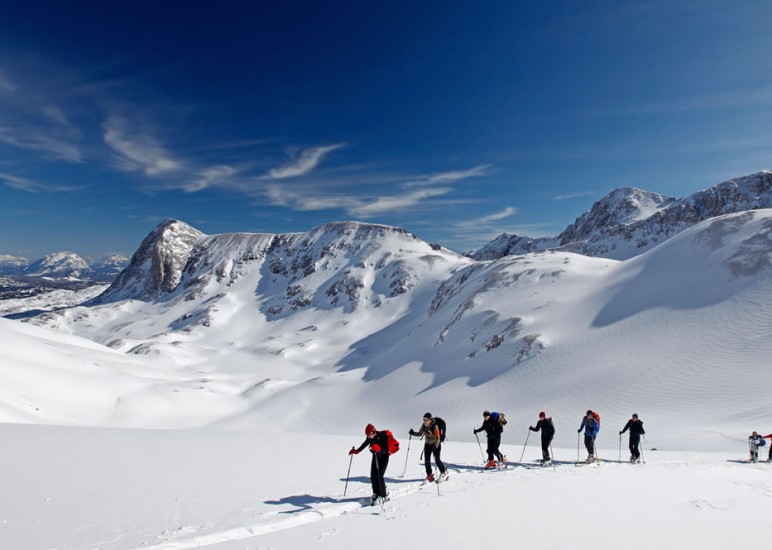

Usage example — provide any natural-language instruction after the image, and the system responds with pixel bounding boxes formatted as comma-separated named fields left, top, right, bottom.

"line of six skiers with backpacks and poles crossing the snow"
left=348, top=410, right=644, bottom=505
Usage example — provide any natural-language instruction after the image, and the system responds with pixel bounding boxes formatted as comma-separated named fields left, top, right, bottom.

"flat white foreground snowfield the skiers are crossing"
left=0, top=422, right=772, bottom=550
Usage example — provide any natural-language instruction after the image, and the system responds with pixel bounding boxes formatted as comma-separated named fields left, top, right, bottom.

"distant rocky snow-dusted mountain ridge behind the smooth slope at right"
left=469, top=170, right=772, bottom=260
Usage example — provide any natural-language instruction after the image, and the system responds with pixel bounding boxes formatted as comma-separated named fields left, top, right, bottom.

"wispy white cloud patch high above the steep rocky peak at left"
left=102, top=116, right=183, bottom=176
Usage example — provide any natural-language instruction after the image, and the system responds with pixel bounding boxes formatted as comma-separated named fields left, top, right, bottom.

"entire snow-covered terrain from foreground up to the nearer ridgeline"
left=0, top=210, right=772, bottom=550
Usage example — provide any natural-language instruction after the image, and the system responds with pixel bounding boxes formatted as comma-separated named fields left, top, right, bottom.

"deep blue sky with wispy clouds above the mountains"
left=0, top=0, right=772, bottom=259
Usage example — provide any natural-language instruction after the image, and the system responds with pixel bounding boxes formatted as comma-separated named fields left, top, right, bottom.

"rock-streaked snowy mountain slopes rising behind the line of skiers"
left=10, top=210, right=772, bottom=448
